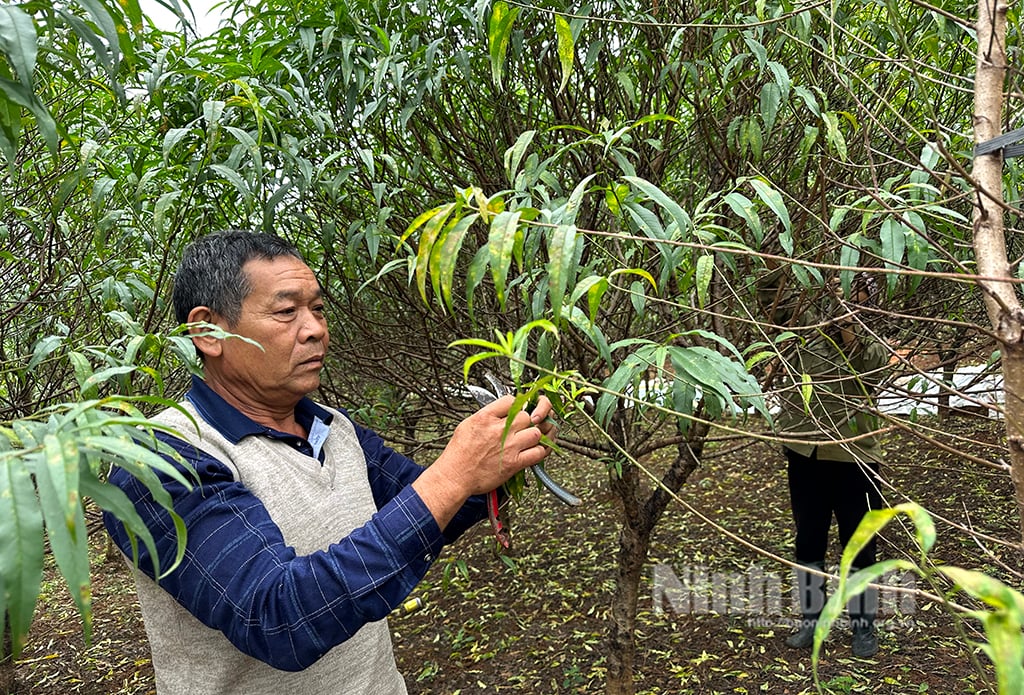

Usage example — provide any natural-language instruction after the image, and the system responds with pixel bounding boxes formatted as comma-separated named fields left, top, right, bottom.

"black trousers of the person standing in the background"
left=785, top=448, right=882, bottom=568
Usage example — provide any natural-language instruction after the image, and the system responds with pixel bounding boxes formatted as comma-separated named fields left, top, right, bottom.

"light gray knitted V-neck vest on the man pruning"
left=135, top=402, right=407, bottom=695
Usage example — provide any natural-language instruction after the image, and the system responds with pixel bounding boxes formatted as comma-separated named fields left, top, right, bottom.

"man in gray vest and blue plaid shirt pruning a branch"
left=105, top=231, right=554, bottom=695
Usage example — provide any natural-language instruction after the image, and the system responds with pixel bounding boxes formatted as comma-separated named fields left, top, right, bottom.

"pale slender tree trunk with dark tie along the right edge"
left=973, top=0, right=1024, bottom=540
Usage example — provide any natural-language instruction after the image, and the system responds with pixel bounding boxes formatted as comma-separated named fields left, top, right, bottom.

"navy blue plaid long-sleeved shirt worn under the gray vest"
left=104, top=379, right=486, bottom=670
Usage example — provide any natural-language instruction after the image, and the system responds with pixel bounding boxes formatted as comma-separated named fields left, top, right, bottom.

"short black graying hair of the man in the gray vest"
left=173, top=229, right=304, bottom=325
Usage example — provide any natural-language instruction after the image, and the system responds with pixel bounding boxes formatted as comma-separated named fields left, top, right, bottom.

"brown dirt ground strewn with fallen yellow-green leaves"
left=6, top=420, right=1020, bottom=695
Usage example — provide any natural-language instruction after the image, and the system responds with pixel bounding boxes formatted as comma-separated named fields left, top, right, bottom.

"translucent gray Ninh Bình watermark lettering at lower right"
left=651, top=563, right=918, bottom=629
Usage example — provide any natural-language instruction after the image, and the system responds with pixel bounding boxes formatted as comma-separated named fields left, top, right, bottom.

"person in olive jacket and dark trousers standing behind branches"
left=760, top=271, right=889, bottom=658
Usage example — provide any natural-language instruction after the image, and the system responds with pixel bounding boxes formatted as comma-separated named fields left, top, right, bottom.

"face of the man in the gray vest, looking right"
left=214, top=256, right=330, bottom=408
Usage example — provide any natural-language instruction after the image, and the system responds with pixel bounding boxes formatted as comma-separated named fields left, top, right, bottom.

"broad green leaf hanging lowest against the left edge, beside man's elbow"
left=0, top=450, right=43, bottom=658
